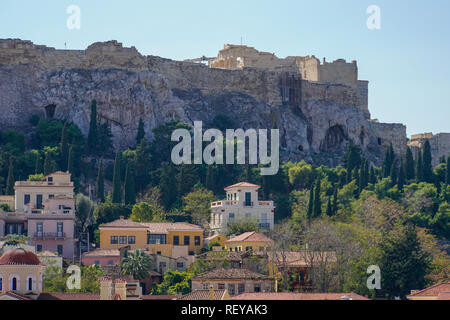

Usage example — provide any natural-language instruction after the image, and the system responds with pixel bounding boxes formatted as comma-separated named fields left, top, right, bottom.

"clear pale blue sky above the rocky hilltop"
left=0, top=0, right=450, bottom=135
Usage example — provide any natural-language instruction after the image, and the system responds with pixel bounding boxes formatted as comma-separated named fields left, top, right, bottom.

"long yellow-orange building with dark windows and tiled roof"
left=99, top=217, right=203, bottom=257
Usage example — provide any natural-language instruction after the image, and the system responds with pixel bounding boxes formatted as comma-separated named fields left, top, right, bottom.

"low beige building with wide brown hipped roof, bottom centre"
left=191, top=268, right=274, bottom=295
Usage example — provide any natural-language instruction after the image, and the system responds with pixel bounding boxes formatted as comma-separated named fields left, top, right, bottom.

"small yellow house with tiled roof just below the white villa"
left=225, top=231, right=273, bottom=252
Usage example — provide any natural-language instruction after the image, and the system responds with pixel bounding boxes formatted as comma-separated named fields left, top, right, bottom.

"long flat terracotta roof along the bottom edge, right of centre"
left=231, top=292, right=370, bottom=300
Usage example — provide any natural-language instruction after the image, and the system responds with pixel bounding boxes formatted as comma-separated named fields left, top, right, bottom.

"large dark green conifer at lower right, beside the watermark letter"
left=380, top=224, right=430, bottom=298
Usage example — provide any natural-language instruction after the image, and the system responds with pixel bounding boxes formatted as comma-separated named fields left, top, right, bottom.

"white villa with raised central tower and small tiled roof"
left=210, top=182, right=275, bottom=233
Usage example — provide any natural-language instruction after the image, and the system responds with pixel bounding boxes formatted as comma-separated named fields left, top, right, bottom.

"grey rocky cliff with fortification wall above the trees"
left=0, top=40, right=406, bottom=166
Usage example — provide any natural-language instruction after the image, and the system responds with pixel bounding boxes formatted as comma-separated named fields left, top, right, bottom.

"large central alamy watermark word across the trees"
left=171, top=121, right=280, bottom=175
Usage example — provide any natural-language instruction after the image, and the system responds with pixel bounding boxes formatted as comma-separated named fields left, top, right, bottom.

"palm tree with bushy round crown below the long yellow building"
left=120, top=249, right=153, bottom=280
